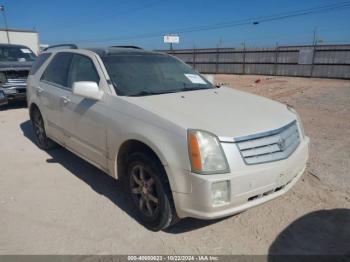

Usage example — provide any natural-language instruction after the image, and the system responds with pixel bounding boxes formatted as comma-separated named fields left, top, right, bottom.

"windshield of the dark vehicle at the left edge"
left=0, top=46, right=35, bottom=62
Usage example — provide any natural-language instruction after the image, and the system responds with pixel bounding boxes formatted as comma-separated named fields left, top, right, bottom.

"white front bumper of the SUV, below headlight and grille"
left=173, top=137, right=309, bottom=219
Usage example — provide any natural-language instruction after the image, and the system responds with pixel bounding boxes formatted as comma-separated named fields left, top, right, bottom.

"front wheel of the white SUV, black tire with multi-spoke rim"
left=123, top=152, right=178, bottom=231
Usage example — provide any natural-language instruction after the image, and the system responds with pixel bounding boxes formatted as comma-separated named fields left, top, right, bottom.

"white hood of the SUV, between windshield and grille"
left=128, top=87, right=296, bottom=140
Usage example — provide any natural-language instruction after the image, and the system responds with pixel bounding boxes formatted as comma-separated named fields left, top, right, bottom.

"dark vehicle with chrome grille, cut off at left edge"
left=0, top=44, right=36, bottom=105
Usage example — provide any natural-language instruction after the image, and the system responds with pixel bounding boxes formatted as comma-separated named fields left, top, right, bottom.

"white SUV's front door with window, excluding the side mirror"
left=62, top=53, right=107, bottom=170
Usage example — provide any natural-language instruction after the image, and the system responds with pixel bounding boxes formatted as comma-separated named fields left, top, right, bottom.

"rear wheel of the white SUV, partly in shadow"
left=30, top=108, right=56, bottom=150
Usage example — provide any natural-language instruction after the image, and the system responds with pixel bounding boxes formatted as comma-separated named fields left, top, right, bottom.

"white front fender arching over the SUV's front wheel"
left=102, top=95, right=190, bottom=193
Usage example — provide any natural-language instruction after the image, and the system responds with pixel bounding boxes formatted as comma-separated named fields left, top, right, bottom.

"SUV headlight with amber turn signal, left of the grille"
left=187, top=130, right=230, bottom=174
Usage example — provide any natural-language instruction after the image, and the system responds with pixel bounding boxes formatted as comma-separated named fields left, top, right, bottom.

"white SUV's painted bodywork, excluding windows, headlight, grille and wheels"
left=27, top=49, right=309, bottom=219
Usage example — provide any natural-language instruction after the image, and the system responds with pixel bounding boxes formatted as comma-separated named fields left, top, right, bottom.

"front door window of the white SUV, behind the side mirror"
left=68, top=54, right=100, bottom=88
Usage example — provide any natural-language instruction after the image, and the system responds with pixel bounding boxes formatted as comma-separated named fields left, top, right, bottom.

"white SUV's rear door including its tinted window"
left=38, top=52, right=73, bottom=144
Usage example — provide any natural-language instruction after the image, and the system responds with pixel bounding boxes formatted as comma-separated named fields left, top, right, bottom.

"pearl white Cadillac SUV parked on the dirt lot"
left=27, top=45, right=309, bottom=231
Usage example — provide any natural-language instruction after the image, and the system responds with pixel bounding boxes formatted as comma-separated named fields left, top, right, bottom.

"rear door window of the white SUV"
left=41, top=53, right=73, bottom=87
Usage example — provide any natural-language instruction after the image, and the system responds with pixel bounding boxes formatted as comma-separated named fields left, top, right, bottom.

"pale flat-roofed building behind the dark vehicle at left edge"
left=0, top=28, right=40, bottom=54
